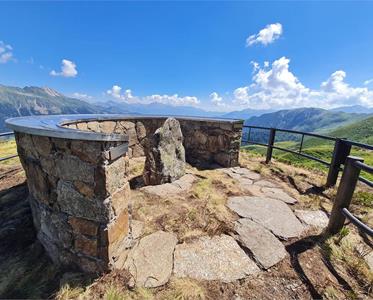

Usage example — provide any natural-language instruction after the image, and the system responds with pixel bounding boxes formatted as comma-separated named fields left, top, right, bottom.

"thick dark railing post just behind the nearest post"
left=326, top=139, right=351, bottom=187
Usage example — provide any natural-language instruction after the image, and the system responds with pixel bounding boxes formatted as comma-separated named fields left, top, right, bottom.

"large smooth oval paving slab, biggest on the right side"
left=228, top=196, right=304, bottom=239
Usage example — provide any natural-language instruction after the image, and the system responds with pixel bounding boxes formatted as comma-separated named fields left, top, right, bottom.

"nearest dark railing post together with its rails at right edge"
left=327, top=156, right=373, bottom=237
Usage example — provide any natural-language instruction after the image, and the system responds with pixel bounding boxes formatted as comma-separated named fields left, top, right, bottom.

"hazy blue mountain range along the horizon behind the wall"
left=0, top=85, right=373, bottom=132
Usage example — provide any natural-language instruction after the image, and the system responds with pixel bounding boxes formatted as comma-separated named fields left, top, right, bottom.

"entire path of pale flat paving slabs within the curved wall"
left=120, top=167, right=328, bottom=287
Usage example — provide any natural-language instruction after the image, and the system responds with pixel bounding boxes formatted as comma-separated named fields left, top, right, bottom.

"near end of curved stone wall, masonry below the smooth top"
left=16, top=132, right=130, bottom=273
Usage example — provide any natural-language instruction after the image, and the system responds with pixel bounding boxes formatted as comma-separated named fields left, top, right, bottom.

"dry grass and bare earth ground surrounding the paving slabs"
left=0, top=153, right=373, bottom=299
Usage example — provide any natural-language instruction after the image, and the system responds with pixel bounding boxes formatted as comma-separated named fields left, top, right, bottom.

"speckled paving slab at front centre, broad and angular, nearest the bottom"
left=174, top=235, right=259, bottom=282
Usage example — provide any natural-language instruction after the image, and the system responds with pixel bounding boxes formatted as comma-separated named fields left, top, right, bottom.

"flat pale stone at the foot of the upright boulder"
left=141, top=174, right=196, bottom=197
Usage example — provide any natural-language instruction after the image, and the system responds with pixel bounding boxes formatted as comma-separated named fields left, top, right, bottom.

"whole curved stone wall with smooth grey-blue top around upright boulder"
left=6, top=115, right=242, bottom=273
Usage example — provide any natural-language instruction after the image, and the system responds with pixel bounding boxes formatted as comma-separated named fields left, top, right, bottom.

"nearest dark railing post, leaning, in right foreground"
left=326, top=156, right=364, bottom=234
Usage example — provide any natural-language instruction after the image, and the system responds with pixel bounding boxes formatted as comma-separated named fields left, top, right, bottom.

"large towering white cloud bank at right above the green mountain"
left=233, top=57, right=373, bottom=108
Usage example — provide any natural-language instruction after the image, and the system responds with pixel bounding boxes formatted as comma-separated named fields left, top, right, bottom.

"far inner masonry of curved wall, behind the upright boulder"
left=65, top=117, right=242, bottom=167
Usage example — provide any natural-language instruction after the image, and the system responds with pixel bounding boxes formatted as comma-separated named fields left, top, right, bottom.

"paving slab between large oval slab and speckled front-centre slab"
left=235, top=219, right=287, bottom=269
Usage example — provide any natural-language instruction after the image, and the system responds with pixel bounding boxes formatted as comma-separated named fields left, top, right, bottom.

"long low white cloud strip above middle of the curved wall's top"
left=106, top=85, right=200, bottom=106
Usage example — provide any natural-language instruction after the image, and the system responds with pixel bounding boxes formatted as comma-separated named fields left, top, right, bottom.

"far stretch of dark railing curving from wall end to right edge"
left=242, top=125, right=373, bottom=186
